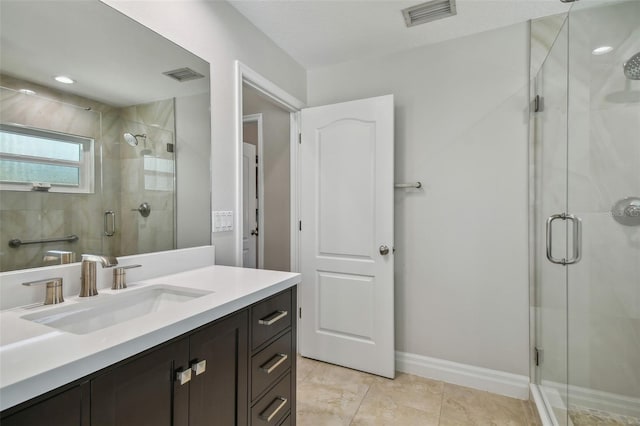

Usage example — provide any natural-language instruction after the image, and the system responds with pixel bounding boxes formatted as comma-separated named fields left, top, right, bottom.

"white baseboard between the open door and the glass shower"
left=396, top=352, right=529, bottom=400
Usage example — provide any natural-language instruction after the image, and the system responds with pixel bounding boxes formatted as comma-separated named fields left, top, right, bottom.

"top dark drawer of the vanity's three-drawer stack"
left=251, top=290, right=294, bottom=350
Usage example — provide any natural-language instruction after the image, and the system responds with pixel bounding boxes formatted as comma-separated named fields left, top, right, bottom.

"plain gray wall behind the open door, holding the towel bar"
left=308, top=23, right=529, bottom=376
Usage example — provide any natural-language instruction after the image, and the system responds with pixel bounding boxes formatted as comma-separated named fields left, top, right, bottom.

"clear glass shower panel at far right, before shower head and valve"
left=567, top=0, right=640, bottom=426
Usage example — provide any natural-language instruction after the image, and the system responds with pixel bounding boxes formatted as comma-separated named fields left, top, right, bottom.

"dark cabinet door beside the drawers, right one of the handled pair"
left=189, top=311, right=249, bottom=426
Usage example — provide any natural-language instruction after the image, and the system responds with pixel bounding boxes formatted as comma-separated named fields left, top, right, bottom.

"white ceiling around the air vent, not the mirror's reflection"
left=227, top=0, right=570, bottom=69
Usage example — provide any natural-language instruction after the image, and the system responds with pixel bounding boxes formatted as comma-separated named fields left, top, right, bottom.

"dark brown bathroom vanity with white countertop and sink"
left=0, top=266, right=300, bottom=426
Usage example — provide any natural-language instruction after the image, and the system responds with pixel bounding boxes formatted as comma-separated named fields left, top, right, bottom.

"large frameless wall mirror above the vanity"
left=0, top=0, right=211, bottom=271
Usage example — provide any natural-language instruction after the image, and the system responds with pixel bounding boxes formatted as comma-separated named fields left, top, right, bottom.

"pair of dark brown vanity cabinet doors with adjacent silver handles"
left=91, top=310, right=248, bottom=426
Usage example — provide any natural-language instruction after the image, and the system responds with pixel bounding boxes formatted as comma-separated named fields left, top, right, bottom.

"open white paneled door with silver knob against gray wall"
left=299, top=95, right=395, bottom=378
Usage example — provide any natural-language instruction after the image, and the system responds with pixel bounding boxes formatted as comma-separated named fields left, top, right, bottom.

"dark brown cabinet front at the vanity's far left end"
left=2, top=384, right=89, bottom=426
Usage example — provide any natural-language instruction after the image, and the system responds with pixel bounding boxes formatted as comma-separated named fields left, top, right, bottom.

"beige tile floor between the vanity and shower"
left=296, top=357, right=541, bottom=426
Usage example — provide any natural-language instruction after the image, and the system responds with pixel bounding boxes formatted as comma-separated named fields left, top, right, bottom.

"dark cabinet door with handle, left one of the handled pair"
left=91, top=338, right=189, bottom=426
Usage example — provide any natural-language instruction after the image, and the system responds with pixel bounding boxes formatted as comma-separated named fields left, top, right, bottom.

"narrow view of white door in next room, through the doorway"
left=242, top=142, right=258, bottom=268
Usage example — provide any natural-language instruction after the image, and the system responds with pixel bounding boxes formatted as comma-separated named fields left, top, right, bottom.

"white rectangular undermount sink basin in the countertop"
left=21, top=285, right=213, bottom=334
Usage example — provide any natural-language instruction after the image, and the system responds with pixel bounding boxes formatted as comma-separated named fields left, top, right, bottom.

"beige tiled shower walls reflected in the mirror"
left=0, top=76, right=175, bottom=271
